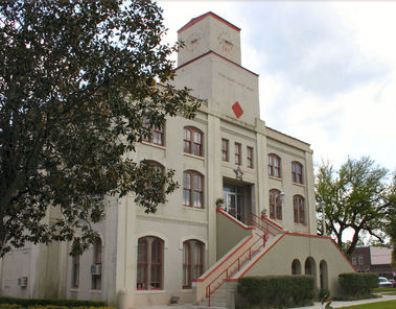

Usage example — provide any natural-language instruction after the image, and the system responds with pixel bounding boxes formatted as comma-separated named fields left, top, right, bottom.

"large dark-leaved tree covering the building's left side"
left=0, top=0, right=198, bottom=256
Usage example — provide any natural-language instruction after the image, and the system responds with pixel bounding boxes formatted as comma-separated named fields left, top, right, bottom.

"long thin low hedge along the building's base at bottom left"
left=0, top=297, right=106, bottom=309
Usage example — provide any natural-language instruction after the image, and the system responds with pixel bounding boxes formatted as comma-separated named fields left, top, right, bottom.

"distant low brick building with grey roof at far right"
left=351, top=247, right=396, bottom=278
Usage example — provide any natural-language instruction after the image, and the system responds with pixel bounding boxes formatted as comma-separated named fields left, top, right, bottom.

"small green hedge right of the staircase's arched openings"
left=338, top=273, right=378, bottom=299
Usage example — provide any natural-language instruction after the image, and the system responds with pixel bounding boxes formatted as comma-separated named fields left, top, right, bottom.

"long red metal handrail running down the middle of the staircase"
left=206, top=234, right=267, bottom=307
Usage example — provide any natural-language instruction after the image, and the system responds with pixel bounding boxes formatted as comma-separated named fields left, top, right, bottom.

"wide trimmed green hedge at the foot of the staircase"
left=236, top=276, right=315, bottom=309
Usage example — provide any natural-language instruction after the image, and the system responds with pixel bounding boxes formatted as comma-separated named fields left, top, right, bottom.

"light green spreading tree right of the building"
left=315, top=157, right=395, bottom=255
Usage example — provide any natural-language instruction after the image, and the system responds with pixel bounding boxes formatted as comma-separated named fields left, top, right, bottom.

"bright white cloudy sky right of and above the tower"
left=159, top=0, right=396, bottom=170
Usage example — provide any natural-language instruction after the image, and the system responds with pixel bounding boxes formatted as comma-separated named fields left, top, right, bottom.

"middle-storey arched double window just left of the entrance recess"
left=183, top=170, right=204, bottom=208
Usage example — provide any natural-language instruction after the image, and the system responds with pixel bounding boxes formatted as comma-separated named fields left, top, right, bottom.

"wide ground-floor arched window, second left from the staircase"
left=136, top=236, right=164, bottom=290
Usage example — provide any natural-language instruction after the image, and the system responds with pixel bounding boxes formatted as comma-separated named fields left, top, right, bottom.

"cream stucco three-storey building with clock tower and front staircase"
left=1, top=12, right=353, bottom=308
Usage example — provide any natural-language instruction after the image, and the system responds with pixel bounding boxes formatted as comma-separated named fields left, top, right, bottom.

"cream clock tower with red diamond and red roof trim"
left=175, top=12, right=260, bottom=126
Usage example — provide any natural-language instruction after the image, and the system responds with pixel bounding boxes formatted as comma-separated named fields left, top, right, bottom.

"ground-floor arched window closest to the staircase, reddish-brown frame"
left=183, top=239, right=204, bottom=289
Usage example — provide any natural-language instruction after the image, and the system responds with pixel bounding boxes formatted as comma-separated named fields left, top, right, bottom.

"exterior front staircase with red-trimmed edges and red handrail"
left=195, top=209, right=285, bottom=308
